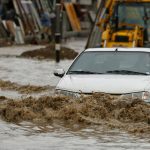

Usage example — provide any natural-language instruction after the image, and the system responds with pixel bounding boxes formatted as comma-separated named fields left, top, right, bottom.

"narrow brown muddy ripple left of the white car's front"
left=0, top=80, right=53, bottom=94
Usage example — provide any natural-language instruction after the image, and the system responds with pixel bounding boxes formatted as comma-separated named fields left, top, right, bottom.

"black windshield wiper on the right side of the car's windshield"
left=106, top=70, right=149, bottom=75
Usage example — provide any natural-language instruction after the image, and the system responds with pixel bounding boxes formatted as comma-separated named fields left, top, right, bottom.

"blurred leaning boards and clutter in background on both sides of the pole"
left=0, top=0, right=98, bottom=44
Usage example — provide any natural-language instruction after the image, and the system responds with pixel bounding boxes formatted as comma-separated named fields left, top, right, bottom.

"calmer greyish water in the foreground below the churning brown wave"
left=0, top=122, right=150, bottom=150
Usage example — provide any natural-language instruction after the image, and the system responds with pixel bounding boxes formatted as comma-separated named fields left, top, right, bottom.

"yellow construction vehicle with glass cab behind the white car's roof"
left=97, top=0, right=150, bottom=47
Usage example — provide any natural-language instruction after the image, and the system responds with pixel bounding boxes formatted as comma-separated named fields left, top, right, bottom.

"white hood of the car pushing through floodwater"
left=56, top=75, right=150, bottom=94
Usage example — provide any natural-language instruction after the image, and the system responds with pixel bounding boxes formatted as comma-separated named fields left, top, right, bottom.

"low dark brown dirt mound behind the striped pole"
left=20, top=44, right=78, bottom=59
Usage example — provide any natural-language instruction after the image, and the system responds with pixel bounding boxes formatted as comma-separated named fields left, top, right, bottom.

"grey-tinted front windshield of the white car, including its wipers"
left=67, top=51, right=150, bottom=75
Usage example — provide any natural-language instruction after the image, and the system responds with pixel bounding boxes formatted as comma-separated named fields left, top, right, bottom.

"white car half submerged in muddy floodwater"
left=54, top=48, right=150, bottom=101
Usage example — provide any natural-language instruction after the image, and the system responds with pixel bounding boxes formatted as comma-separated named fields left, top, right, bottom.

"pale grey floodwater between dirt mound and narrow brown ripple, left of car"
left=0, top=57, right=72, bottom=86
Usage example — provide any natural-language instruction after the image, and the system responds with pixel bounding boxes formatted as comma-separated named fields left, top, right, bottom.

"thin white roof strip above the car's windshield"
left=85, top=47, right=150, bottom=52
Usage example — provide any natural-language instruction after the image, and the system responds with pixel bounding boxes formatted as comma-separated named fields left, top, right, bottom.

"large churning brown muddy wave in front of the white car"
left=0, top=93, right=150, bottom=134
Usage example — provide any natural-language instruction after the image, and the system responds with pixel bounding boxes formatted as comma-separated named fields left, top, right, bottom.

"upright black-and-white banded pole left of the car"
left=55, top=0, right=61, bottom=63
